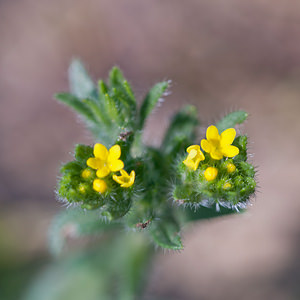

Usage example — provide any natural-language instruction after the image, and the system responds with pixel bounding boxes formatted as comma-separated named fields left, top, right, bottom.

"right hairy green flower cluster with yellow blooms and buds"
left=173, top=125, right=256, bottom=208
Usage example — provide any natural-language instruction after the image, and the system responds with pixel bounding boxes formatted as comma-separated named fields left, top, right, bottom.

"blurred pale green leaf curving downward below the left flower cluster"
left=49, top=208, right=119, bottom=255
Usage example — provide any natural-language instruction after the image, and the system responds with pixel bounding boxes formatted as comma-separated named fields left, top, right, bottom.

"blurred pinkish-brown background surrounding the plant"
left=0, top=0, right=300, bottom=300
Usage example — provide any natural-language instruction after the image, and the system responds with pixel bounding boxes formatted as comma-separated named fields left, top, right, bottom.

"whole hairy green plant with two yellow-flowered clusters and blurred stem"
left=24, top=60, right=256, bottom=299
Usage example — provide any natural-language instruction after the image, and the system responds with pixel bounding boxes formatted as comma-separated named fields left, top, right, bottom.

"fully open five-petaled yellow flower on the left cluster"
left=86, top=144, right=124, bottom=178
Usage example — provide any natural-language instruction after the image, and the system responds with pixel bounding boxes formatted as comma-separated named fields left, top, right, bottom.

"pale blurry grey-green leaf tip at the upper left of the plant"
left=69, top=59, right=96, bottom=98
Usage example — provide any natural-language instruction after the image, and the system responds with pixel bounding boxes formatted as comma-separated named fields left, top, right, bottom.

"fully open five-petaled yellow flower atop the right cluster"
left=201, top=125, right=239, bottom=160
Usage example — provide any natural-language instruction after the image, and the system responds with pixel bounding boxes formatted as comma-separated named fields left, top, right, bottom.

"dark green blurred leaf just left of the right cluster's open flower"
left=161, top=105, right=199, bottom=155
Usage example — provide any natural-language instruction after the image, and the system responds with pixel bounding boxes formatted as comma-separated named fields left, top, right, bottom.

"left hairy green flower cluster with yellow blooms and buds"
left=58, top=143, right=135, bottom=209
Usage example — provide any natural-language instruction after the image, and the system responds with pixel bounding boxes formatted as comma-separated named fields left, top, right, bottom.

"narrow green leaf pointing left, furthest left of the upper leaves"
left=54, top=93, right=96, bottom=123
